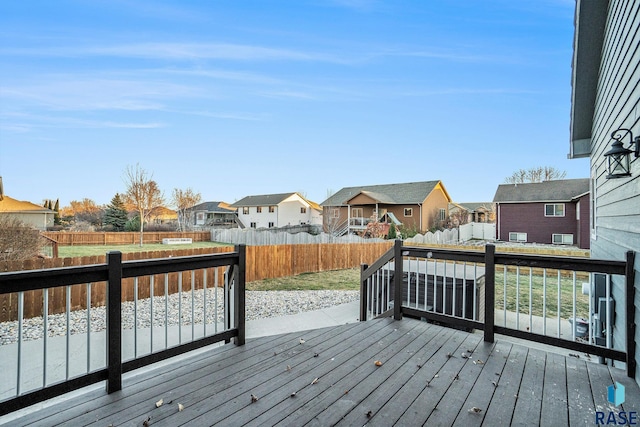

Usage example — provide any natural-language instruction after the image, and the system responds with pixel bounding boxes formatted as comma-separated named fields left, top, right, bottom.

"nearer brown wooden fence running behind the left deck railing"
left=0, top=242, right=392, bottom=322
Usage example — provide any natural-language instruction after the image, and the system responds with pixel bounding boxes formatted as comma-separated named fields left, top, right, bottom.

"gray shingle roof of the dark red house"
left=493, top=178, right=589, bottom=203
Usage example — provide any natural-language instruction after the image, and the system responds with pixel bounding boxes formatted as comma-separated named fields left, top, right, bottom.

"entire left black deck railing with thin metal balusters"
left=0, top=245, right=246, bottom=415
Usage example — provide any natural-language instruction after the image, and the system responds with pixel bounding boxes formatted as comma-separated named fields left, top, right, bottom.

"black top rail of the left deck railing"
left=0, top=251, right=239, bottom=294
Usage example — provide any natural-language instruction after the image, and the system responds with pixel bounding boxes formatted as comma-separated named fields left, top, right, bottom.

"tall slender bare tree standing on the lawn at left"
left=123, top=164, right=164, bottom=246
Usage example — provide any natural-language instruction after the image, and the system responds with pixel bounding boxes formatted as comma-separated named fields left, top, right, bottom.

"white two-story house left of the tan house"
left=231, top=193, right=322, bottom=228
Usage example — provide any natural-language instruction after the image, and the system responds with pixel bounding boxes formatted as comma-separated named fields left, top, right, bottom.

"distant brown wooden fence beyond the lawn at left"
left=42, top=231, right=211, bottom=246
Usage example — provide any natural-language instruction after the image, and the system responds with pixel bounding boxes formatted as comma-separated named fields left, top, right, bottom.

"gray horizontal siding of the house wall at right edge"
left=572, top=0, right=640, bottom=382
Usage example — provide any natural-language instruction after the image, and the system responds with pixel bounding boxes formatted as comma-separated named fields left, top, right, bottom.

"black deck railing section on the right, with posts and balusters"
left=360, top=240, right=636, bottom=376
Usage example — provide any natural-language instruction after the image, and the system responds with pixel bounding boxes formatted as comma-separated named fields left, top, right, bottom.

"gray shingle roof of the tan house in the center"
left=320, top=181, right=440, bottom=206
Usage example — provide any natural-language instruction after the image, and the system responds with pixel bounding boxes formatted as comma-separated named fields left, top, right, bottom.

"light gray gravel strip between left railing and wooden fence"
left=0, top=288, right=360, bottom=345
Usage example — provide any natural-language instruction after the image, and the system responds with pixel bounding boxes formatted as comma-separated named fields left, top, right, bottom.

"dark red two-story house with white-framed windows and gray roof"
left=493, top=178, right=590, bottom=249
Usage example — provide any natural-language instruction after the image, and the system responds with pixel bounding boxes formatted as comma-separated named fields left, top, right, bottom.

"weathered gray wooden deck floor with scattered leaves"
left=6, top=319, right=640, bottom=426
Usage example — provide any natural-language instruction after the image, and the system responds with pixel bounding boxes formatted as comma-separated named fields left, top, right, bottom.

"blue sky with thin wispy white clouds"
left=0, top=0, right=589, bottom=206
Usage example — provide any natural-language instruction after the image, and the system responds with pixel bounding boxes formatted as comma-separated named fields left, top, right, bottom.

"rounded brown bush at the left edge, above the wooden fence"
left=0, top=215, right=44, bottom=261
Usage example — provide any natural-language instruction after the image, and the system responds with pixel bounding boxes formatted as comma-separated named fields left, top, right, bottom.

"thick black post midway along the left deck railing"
left=107, top=251, right=122, bottom=393
